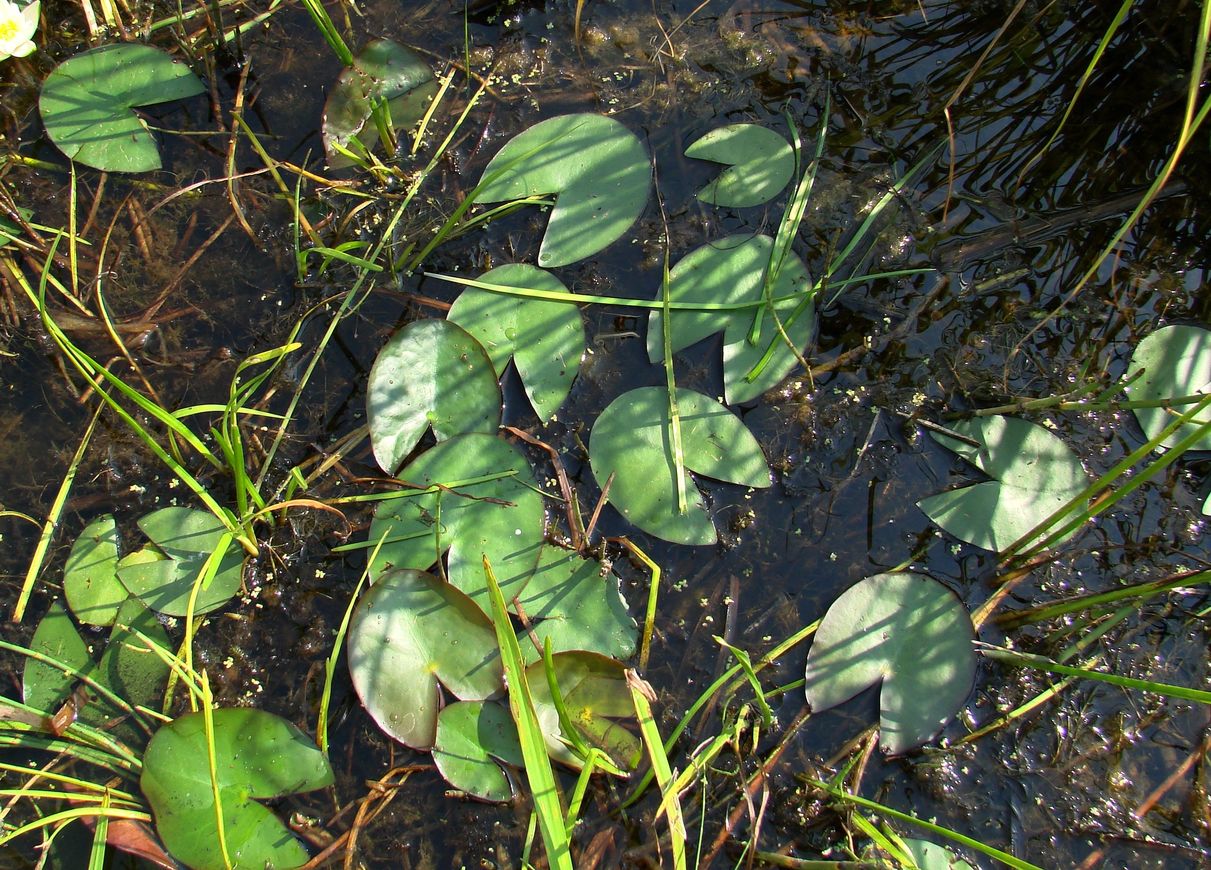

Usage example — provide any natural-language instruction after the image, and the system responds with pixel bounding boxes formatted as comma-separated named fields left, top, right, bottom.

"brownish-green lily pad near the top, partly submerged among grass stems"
left=323, top=39, right=437, bottom=165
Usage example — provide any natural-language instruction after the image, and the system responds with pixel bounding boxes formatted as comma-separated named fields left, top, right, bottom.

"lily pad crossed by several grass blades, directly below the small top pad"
left=648, top=235, right=815, bottom=403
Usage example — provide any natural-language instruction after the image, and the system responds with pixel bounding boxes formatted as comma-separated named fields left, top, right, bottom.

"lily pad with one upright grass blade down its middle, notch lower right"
left=589, top=387, right=770, bottom=545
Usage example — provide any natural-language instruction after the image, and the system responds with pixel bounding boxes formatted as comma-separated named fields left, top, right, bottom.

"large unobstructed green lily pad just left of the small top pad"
left=476, top=114, right=652, bottom=268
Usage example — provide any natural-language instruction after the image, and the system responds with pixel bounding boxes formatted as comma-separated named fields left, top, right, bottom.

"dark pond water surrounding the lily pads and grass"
left=0, top=0, right=1211, bottom=868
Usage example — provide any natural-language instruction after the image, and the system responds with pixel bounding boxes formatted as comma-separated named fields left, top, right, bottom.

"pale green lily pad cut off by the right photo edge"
left=1126, top=326, right=1211, bottom=450
